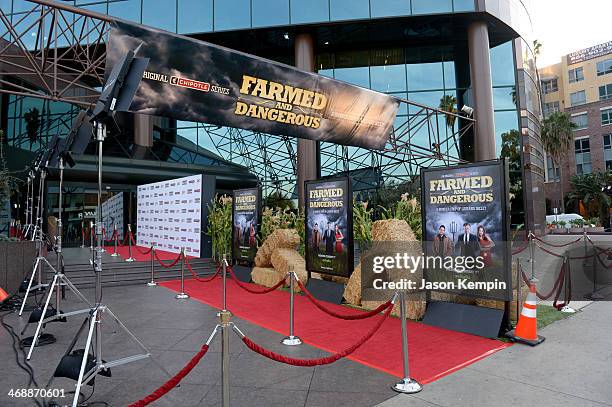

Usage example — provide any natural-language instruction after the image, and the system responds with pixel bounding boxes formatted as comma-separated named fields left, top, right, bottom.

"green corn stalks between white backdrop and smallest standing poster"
left=206, top=195, right=232, bottom=260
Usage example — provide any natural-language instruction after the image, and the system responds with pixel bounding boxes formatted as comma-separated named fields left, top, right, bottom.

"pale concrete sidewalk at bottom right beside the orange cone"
left=379, top=302, right=612, bottom=407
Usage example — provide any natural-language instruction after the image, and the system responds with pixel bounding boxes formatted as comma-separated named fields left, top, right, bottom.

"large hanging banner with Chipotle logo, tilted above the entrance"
left=106, top=21, right=399, bottom=149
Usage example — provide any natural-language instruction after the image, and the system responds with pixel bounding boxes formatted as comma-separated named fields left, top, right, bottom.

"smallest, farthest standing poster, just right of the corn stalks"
left=232, top=188, right=261, bottom=263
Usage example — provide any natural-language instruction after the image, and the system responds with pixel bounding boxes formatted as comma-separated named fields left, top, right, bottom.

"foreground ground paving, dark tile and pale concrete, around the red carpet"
left=0, top=256, right=612, bottom=407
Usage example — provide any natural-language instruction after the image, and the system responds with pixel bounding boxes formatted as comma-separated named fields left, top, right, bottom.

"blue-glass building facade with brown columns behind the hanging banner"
left=0, top=0, right=546, bottom=230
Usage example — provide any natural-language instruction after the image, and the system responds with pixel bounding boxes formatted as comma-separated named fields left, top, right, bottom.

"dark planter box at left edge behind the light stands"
left=0, top=241, right=36, bottom=294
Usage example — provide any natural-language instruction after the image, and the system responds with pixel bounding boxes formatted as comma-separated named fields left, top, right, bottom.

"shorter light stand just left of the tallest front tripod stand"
left=22, top=157, right=92, bottom=360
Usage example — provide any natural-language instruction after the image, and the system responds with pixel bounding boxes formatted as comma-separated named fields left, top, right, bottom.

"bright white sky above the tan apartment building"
left=530, top=0, right=612, bottom=68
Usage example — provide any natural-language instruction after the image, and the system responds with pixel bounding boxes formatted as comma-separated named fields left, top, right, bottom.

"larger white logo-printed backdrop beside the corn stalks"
left=136, top=175, right=202, bottom=257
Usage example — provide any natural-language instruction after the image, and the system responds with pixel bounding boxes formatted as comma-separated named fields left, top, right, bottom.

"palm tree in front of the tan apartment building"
left=541, top=112, right=576, bottom=213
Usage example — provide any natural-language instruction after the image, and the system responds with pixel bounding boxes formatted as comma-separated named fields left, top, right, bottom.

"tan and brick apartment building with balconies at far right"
left=540, top=41, right=612, bottom=211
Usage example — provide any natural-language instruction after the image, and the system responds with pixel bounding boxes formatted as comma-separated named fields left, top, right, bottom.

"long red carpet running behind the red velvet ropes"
left=160, top=278, right=511, bottom=383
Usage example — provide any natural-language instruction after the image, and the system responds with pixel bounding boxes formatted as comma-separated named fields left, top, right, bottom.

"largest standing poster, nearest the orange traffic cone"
left=421, top=160, right=512, bottom=300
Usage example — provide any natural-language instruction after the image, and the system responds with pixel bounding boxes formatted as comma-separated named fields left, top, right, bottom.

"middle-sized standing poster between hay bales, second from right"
left=304, top=178, right=353, bottom=277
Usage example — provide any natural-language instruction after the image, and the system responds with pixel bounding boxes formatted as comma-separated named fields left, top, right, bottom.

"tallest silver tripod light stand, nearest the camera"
left=52, top=123, right=171, bottom=407
